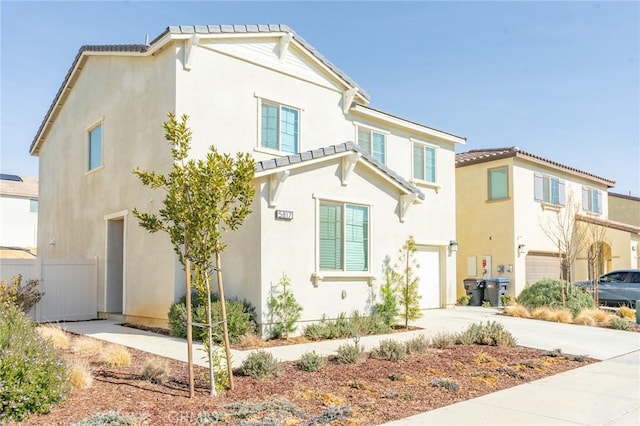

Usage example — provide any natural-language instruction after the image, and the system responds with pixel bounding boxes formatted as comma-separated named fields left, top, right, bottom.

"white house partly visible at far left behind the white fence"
left=0, top=173, right=38, bottom=258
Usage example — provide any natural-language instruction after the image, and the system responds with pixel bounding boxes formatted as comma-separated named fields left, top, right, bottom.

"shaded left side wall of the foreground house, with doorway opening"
left=38, top=46, right=175, bottom=319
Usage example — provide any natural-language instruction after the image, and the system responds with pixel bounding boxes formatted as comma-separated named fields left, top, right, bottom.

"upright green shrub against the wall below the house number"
left=267, top=274, right=302, bottom=339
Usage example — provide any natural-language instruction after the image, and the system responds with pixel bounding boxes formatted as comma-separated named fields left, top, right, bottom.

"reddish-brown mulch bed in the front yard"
left=16, top=336, right=594, bottom=426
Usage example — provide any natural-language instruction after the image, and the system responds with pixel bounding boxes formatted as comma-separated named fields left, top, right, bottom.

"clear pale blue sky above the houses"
left=0, top=0, right=640, bottom=196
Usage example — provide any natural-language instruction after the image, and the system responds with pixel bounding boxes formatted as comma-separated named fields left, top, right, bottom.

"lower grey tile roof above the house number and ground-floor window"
left=256, top=142, right=425, bottom=200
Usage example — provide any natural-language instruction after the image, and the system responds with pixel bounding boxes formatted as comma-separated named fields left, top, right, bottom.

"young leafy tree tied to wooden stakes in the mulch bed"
left=133, top=113, right=255, bottom=395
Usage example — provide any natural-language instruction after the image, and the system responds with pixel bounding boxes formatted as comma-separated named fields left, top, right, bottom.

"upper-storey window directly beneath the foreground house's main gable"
left=260, top=102, right=300, bottom=154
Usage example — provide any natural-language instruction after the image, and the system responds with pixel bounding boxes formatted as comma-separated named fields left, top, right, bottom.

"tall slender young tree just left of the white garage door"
left=395, top=236, right=422, bottom=328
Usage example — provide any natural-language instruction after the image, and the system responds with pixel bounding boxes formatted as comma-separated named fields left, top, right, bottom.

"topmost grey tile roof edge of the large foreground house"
left=29, top=25, right=370, bottom=153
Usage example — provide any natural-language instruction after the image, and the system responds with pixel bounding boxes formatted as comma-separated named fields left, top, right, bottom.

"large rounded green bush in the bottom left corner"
left=0, top=304, right=69, bottom=423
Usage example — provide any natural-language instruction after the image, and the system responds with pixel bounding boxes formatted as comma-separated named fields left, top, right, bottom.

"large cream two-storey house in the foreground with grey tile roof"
left=31, top=25, right=465, bottom=325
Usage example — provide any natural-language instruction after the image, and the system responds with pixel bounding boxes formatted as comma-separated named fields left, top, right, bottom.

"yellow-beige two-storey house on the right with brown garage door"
left=456, top=147, right=640, bottom=296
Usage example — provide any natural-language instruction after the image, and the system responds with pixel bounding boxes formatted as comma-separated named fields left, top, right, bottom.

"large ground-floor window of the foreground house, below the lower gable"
left=319, top=202, right=369, bottom=272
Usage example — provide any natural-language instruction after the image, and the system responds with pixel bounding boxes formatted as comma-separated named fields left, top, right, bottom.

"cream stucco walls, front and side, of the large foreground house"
left=38, top=36, right=456, bottom=325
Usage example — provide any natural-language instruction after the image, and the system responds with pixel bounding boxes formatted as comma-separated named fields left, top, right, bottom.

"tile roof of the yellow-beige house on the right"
left=456, top=146, right=616, bottom=187
